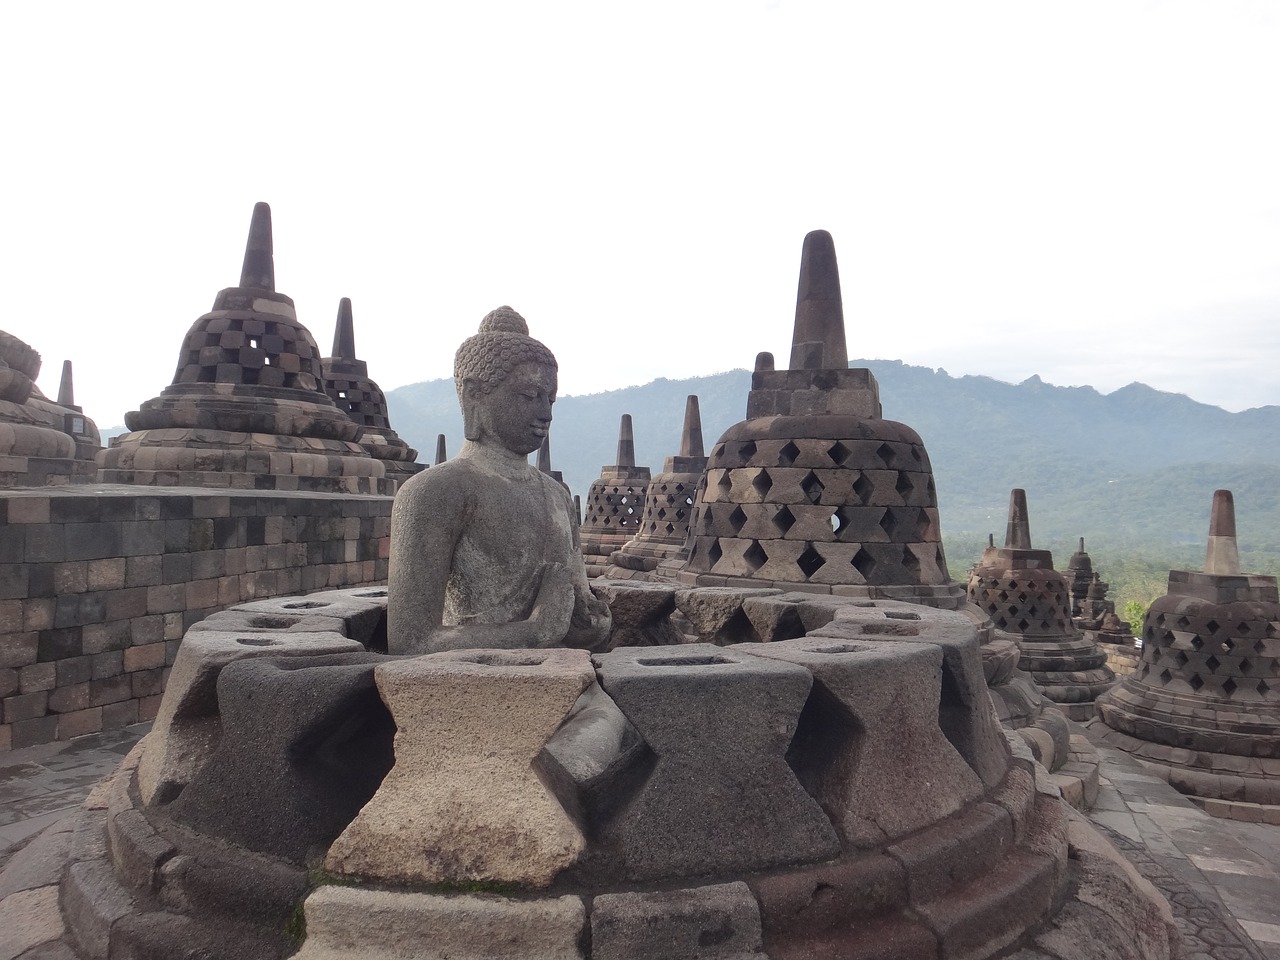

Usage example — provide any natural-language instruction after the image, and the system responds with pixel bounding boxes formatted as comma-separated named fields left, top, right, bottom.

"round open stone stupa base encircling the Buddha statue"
left=6, top=585, right=1175, bottom=960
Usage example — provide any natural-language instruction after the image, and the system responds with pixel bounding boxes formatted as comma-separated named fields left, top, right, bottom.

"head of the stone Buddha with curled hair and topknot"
left=453, top=306, right=558, bottom=456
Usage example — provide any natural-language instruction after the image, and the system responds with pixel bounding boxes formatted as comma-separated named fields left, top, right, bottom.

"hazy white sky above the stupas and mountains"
left=0, top=0, right=1280, bottom=428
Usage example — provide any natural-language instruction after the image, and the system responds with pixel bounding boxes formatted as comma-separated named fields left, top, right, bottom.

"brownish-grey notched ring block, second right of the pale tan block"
left=730, top=637, right=982, bottom=847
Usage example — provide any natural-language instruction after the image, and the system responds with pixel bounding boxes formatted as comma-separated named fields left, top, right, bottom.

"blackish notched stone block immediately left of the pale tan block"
left=169, top=653, right=394, bottom=863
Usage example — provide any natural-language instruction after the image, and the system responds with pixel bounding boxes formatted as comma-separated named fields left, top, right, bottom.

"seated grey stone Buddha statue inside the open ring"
left=387, top=306, right=611, bottom=654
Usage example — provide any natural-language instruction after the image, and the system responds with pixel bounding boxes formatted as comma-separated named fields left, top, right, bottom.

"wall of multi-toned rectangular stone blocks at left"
left=0, top=485, right=392, bottom=750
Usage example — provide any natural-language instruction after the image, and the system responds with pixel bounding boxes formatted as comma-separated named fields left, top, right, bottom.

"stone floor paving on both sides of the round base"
left=0, top=723, right=1280, bottom=960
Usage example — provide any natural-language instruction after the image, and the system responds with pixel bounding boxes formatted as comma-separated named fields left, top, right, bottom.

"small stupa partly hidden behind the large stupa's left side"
left=605, top=394, right=707, bottom=580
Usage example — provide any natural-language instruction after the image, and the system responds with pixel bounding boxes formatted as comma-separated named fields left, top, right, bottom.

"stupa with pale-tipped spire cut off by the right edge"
left=1092, top=490, right=1280, bottom=823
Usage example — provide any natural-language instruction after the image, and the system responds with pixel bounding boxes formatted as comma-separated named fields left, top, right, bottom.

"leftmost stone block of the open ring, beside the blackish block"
left=138, top=631, right=364, bottom=805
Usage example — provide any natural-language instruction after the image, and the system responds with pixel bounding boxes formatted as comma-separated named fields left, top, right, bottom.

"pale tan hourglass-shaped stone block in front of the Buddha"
left=326, top=648, right=595, bottom=887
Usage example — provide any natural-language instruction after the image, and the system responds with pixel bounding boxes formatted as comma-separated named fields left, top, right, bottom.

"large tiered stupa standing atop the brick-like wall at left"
left=99, top=204, right=396, bottom=494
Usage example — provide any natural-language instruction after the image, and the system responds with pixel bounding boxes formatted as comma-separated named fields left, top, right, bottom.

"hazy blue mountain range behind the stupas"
left=387, top=360, right=1280, bottom=563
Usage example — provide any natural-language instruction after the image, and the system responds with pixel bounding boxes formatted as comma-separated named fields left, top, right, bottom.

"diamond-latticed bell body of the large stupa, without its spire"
left=681, top=415, right=950, bottom=593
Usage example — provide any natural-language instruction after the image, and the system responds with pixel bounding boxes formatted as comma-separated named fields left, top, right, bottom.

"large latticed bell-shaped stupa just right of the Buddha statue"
left=678, top=230, right=964, bottom=608
